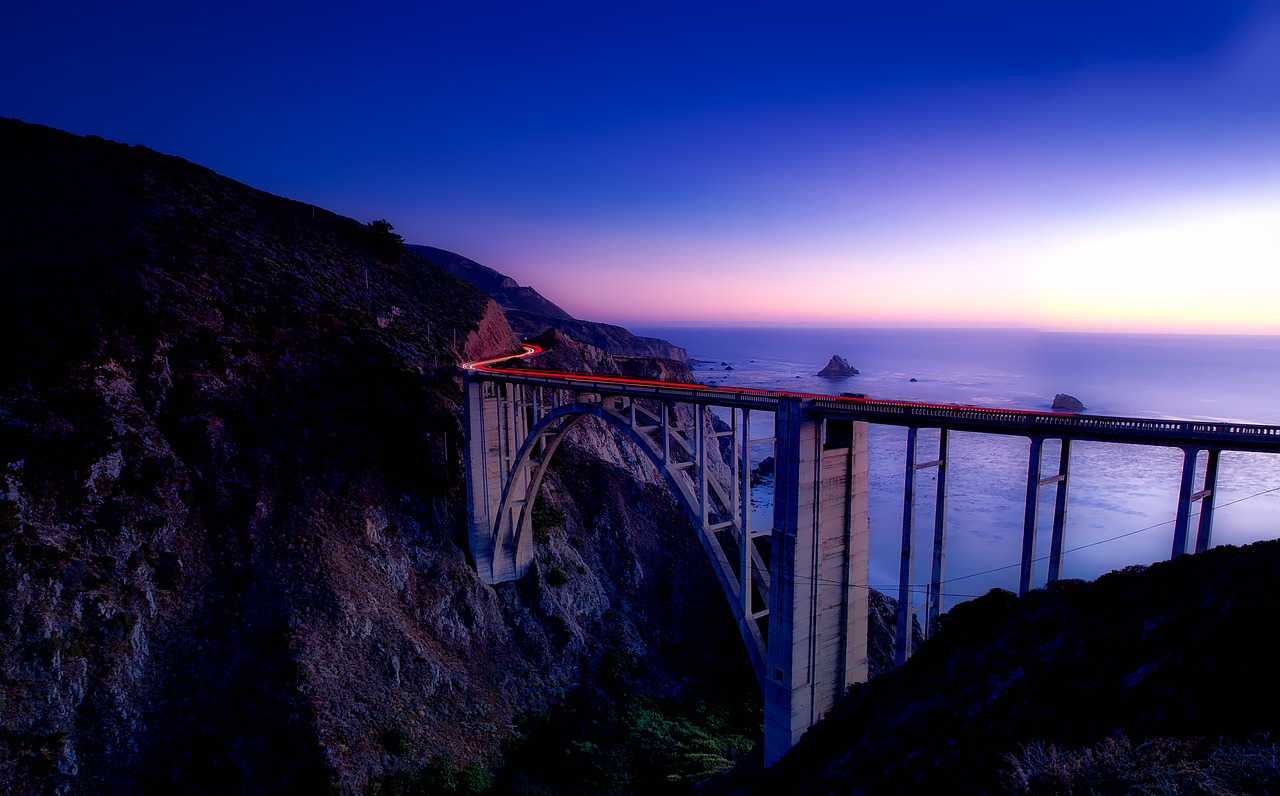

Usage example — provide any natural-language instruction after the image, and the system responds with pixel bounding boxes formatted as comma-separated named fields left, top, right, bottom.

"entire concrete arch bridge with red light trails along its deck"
left=463, top=346, right=1280, bottom=765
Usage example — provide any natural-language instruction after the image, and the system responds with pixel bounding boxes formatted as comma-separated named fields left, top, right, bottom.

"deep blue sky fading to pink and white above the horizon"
left=0, top=0, right=1280, bottom=334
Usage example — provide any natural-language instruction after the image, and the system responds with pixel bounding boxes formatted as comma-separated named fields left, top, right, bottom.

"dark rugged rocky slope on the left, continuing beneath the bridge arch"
left=0, top=120, right=758, bottom=793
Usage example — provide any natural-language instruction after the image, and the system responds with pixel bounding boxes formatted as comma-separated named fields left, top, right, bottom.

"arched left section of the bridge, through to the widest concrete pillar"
left=463, top=371, right=869, bottom=764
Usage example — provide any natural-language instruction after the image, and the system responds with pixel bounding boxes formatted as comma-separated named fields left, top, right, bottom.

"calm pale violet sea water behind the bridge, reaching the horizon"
left=634, top=328, right=1280, bottom=604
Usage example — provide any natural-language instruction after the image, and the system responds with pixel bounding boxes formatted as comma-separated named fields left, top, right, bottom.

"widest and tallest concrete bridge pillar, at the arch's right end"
left=763, top=397, right=870, bottom=765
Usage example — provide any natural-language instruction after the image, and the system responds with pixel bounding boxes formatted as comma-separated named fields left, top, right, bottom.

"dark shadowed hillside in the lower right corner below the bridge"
left=704, top=541, right=1280, bottom=795
